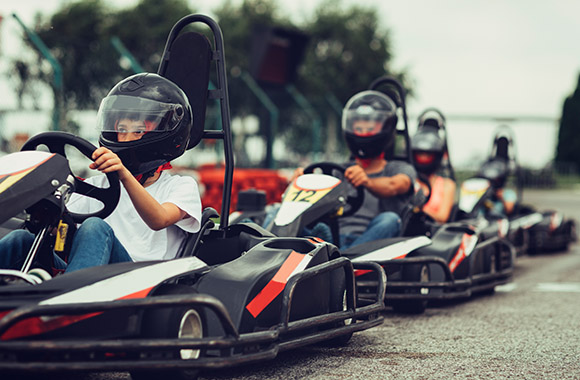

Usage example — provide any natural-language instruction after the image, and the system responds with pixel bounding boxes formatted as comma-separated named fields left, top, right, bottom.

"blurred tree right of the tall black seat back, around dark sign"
left=215, top=0, right=406, bottom=162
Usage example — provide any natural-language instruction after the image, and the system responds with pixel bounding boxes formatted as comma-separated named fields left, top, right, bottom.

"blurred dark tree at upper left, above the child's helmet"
left=16, top=0, right=191, bottom=113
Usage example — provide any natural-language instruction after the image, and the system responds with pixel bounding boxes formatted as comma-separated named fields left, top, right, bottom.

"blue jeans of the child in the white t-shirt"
left=0, top=218, right=133, bottom=273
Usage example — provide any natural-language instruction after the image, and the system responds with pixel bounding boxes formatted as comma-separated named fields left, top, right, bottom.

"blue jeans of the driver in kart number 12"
left=340, top=211, right=401, bottom=249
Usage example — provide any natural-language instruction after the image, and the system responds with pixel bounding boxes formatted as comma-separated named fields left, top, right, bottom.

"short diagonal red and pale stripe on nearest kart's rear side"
left=246, top=251, right=306, bottom=318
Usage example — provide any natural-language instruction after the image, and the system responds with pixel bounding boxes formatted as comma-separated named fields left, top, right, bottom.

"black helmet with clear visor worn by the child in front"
left=97, top=73, right=193, bottom=175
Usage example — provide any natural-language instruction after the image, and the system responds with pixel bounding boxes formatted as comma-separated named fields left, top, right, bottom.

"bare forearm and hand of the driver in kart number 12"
left=344, top=165, right=412, bottom=198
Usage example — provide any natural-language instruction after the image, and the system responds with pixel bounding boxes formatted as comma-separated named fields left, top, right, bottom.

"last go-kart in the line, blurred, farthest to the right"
left=459, top=125, right=577, bottom=255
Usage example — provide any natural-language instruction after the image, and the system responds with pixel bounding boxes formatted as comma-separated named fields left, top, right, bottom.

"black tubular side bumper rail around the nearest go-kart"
left=0, top=257, right=386, bottom=372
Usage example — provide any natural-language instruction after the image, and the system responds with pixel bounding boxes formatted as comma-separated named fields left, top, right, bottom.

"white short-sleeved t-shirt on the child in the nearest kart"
left=67, top=171, right=201, bottom=261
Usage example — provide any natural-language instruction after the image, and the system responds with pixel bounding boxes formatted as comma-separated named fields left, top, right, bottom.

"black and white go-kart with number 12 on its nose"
left=237, top=77, right=515, bottom=313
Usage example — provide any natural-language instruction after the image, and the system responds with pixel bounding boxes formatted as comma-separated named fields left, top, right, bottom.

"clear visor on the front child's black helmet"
left=97, top=95, right=184, bottom=141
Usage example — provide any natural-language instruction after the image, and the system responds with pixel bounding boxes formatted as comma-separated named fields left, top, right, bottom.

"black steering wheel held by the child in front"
left=21, top=132, right=121, bottom=223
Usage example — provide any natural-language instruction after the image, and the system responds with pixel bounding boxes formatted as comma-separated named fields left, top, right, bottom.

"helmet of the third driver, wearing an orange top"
left=411, top=124, right=445, bottom=175
